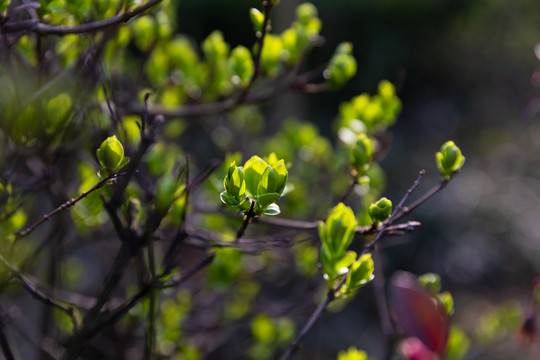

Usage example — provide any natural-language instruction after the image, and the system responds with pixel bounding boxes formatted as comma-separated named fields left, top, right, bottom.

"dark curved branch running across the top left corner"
left=1, top=0, right=162, bottom=36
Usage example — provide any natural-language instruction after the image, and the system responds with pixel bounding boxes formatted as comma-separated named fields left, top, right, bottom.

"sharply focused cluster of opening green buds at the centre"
left=220, top=156, right=288, bottom=215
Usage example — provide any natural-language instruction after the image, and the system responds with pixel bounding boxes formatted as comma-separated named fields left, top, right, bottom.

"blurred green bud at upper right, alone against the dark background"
left=323, top=43, right=357, bottom=89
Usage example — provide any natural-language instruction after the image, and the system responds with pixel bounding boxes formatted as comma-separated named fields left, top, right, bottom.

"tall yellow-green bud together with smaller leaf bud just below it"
left=319, top=203, right=374, bottom=296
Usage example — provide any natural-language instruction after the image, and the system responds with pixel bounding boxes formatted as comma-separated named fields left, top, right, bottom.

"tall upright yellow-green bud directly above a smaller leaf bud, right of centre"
left=319, top=203, right=356, bottom=258
